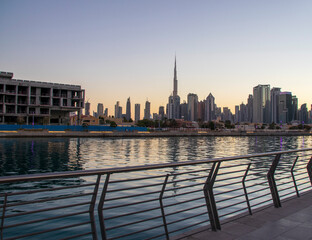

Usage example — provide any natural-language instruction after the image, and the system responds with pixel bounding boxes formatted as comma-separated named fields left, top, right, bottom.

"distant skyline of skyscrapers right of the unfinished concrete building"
left=82, top=57, right=312, bottom=127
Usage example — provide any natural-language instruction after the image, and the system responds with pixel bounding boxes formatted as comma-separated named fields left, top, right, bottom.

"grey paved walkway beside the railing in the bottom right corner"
left=180, top=191, right=312, bottom=240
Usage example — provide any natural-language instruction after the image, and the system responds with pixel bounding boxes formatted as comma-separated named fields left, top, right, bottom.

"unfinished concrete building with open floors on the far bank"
left=0, top=72, right=85, bottom=125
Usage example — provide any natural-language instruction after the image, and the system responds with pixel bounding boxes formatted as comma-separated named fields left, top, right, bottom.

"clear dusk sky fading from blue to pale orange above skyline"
left=0, top=0, right=312, bottom=118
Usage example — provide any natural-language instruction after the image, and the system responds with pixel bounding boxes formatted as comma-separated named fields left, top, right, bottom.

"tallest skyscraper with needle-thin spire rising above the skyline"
left=167, top=58, right=180, bottom=119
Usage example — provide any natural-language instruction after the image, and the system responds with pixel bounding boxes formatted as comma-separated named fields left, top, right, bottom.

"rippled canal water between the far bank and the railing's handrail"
left=0, top=136, right=312, bottom=175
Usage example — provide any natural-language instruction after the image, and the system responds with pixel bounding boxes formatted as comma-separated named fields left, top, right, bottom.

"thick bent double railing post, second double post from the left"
left=203, top=162, right=221, bottom=231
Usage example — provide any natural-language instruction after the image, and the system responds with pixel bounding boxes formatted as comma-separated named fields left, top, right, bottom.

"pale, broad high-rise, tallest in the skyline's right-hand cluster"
left=253, top=85, right=270, bottom=123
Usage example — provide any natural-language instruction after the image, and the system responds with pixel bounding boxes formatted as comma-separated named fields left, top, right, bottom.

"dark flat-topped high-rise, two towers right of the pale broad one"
left=278, top=92, right=293, bottom=123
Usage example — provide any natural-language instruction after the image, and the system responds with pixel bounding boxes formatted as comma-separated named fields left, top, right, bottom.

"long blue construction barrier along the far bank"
left=0, top=124, right=147, bottom=132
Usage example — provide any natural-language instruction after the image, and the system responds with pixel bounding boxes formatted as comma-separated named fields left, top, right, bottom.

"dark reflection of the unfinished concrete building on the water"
left=0, top=138, right=81, bottom=175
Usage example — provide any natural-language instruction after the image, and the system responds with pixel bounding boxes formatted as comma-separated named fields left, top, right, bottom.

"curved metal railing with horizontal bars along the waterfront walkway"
left=0, top=148, right=312, bottom=239
